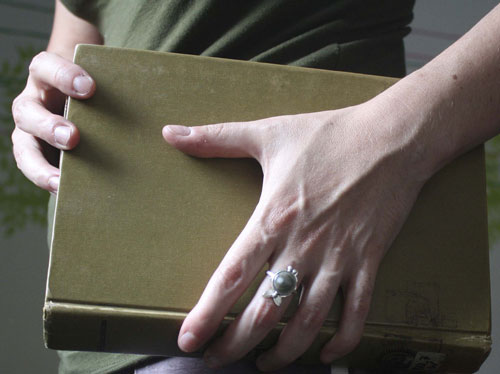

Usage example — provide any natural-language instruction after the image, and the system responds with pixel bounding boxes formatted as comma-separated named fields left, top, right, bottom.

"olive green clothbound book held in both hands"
left=44, top=45, right=491, bottom=372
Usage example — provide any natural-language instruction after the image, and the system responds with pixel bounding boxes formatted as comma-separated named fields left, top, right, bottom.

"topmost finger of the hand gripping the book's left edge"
left=28, top=52, right=96, bottom=99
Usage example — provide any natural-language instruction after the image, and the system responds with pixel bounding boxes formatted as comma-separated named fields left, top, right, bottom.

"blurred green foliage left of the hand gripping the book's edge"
left=0, top=46, right=48, bottom=236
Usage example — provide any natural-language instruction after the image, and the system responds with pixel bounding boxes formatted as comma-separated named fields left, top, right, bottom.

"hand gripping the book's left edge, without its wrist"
left=12, top=52, right=96, bottom=193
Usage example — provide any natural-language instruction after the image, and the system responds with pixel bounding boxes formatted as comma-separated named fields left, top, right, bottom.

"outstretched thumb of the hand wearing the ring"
left=162, top=121, right=262, bottom=158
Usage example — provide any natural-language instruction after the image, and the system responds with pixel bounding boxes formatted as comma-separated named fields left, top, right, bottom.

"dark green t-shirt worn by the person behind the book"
left=53, top=0, right=415, bottom=374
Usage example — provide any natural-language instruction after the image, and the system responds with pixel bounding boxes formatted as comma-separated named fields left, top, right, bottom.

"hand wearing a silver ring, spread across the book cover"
left=163, top=102, right=425, bottom=370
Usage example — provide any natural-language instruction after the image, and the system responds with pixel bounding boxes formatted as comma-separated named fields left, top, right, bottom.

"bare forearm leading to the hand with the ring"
left=372, top=2, right=500, bottom=177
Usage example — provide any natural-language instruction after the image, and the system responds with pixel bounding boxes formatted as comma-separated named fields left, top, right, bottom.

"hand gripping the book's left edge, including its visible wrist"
left=12, top=1, right=102, bottom=193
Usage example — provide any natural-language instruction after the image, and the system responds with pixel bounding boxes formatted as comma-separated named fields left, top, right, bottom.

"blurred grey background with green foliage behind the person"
left=0, top=0, right=500, bottom=374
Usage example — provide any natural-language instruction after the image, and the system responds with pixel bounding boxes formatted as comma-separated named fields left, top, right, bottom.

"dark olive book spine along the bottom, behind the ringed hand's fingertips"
left=44, top=301, right=491, bottom=373
